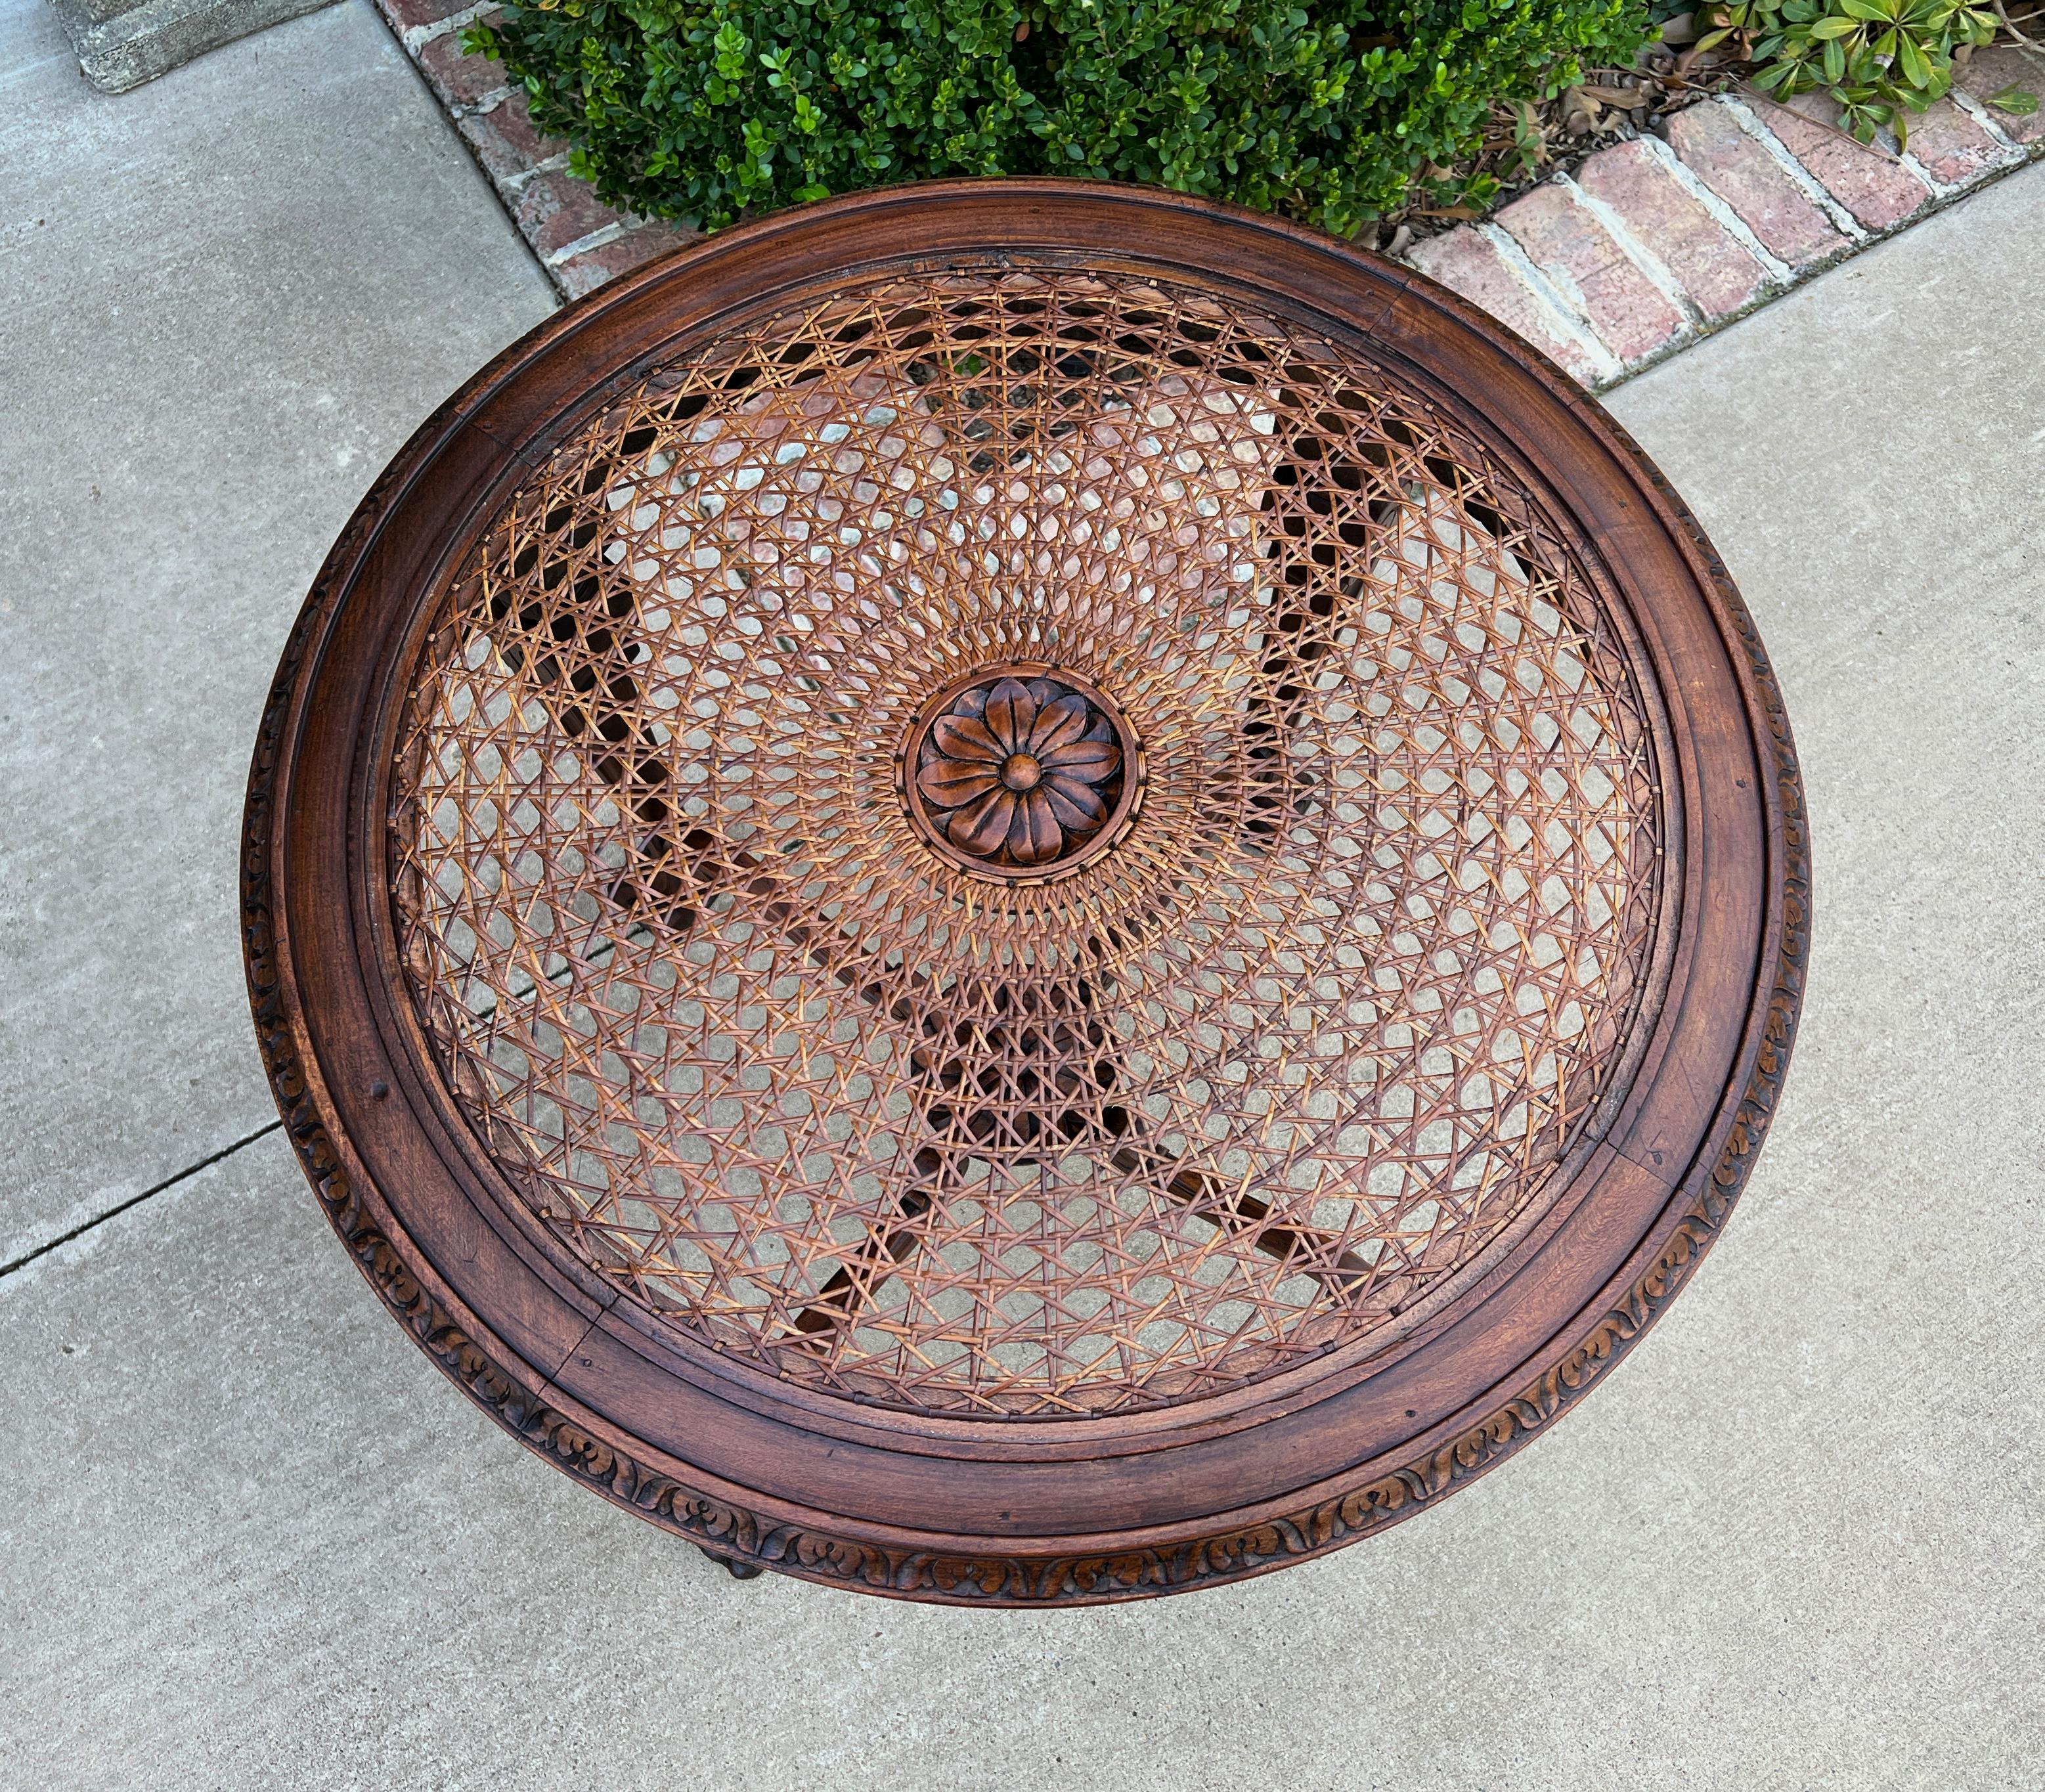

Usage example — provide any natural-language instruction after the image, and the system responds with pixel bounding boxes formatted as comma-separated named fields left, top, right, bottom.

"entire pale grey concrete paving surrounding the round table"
left=0, top=0, right=2045, bottom=1792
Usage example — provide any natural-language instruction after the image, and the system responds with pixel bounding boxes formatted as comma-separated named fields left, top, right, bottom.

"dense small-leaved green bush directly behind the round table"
left=468, top=0, right=1648, bottom=235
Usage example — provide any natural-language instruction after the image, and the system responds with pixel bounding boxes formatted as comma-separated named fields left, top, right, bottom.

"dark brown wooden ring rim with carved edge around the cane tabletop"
left=244, top=182, right=1810, bottom=1604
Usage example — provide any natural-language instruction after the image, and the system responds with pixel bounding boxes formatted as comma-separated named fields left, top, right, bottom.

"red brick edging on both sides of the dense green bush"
left=376, top=0, right=2045, bottom=378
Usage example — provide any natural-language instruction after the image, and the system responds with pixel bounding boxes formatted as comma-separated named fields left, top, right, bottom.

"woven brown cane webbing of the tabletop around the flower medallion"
left=389, top=270, right=1661, bottom=1416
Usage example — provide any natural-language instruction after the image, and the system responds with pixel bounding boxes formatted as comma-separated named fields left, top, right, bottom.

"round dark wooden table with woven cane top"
left=244, top=182, right=1808, bottom=1606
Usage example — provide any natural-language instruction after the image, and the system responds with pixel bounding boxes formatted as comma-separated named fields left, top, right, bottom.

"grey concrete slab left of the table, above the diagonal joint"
left=0, top=0, right=554, bottom=1264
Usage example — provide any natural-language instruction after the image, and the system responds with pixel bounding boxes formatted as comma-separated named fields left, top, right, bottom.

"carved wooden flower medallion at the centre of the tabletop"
left=902, top=663, right=1143, bottom=882
